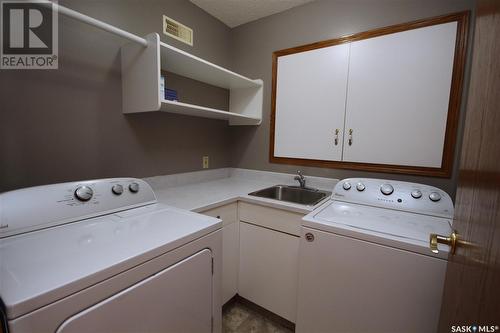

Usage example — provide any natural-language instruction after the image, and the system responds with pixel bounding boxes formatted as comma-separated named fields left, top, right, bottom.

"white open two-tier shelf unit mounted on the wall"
left=122, top=33, right=263, bottom=125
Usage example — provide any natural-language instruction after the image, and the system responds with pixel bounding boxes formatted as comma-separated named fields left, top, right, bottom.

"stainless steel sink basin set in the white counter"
left=248, top=185, right=332, bottom=206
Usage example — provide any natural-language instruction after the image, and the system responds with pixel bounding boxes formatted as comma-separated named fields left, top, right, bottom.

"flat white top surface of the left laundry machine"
left=0, top=204, right=222, bottom=319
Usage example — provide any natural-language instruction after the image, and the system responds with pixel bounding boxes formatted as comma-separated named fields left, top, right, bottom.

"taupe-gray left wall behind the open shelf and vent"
left=0, top=0, right=230, bottom=192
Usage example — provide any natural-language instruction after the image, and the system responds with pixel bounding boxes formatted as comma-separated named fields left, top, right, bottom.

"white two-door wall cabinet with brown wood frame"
left=270, top=12, right=468, bottom=177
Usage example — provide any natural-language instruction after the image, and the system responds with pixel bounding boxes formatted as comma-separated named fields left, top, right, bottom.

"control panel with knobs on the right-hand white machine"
left=332, top=178, right=453, bottom=218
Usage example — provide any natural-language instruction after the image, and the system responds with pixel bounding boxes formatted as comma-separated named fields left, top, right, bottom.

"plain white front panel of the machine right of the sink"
left=296, top=228, right=446, bottom=333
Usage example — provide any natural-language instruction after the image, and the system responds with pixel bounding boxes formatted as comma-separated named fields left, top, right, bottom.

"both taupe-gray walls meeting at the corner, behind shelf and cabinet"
left=0, top=0, right=472, bottom=194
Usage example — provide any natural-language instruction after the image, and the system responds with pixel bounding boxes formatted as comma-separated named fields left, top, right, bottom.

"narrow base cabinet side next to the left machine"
left=202, top=203, right=240, bottom=304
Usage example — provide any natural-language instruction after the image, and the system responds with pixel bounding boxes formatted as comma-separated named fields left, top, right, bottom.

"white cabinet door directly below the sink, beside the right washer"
left=238, top=222, right=300, bottom=322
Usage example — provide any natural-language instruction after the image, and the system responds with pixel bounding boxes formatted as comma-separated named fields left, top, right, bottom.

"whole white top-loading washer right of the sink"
left=296, top=178, right=453, bottom=333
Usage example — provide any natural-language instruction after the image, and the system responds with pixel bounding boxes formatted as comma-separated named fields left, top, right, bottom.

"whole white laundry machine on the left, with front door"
left=0, top=178, right=222, bottom=333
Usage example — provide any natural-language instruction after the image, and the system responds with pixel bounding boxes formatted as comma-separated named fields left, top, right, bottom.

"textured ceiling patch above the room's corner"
left=189, top=0, right=314, bottom=28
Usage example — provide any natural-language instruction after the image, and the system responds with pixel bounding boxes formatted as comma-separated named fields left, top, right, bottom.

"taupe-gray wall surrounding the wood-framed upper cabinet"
left=231, top=0, right=473, bottom=196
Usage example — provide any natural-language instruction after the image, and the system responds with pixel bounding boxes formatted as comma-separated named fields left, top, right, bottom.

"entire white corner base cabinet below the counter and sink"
left=202, top=201, right=303, bottom=323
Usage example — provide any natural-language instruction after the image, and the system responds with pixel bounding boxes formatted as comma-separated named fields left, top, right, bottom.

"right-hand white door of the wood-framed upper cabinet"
left=343, top=22, right=457, bottom=167
